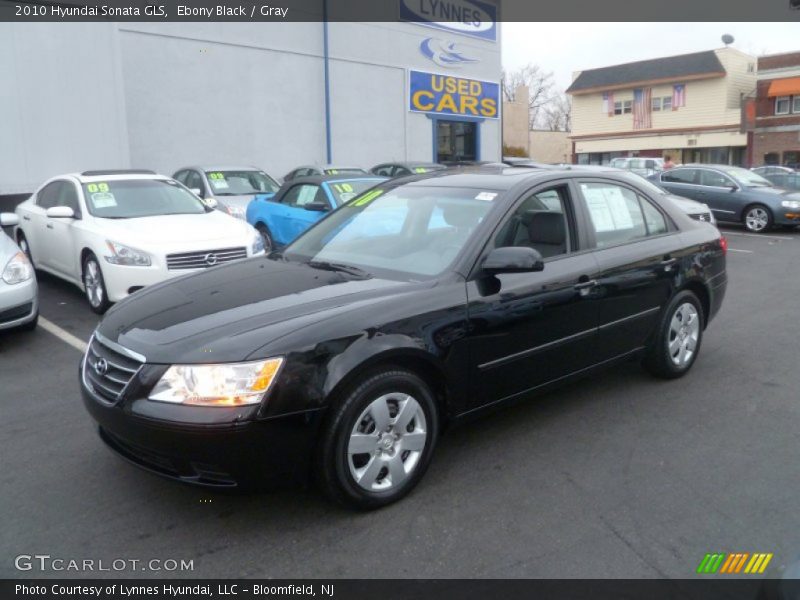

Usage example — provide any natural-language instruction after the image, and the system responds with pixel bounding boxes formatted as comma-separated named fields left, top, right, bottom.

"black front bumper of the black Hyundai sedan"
left=79, top=361, right=320, bottom=488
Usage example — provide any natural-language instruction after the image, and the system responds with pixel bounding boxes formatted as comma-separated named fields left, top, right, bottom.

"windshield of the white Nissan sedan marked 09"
left=83, top=179, right=207, bottom=219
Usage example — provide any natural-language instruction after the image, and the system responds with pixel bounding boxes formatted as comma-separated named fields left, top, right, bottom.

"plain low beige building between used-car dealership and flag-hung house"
left=503, top=85, right=572, bottom=163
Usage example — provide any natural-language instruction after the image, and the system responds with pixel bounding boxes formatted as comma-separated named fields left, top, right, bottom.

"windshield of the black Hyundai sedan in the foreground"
left=284, top=185, right=499, bottom=280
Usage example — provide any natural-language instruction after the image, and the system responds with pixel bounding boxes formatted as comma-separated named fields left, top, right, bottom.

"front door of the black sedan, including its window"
left=467, top=181, right=598, bottom=408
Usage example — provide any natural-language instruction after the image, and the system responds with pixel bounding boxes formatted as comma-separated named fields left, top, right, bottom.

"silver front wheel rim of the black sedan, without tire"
left=347, top=392, right=428, bottom=492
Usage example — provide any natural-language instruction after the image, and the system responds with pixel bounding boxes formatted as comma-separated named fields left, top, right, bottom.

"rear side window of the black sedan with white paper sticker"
left=580, top=182, right=669, bottom=248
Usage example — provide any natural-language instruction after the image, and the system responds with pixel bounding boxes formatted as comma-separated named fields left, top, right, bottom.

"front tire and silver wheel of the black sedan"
left=314, top=368, right=439, bottom=510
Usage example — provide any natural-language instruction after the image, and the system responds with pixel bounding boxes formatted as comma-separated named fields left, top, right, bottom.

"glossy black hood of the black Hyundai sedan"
left=98, top=257, right=422, bottom=364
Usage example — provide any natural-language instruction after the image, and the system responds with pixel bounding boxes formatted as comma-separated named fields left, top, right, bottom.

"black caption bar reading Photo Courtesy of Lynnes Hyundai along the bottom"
left=0, top=578, right=800, bottom=600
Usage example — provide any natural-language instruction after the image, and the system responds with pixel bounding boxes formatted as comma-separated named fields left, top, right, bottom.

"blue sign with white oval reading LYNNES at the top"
left=399, top=0, right=497, bottom=42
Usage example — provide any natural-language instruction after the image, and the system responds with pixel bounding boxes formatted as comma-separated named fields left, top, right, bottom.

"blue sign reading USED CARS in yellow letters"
left=408, top=71, right=500, bottom=119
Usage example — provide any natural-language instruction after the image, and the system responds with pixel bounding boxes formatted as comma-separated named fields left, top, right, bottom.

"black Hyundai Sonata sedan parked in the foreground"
left=80, top=169, right=727, bottom=508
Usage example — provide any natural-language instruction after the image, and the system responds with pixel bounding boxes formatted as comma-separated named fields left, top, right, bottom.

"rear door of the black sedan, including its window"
left=578, top=179, right=687, bottom=362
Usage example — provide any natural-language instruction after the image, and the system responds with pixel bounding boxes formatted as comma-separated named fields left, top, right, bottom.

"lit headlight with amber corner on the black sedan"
left=149, top=358, right=283, bottom=406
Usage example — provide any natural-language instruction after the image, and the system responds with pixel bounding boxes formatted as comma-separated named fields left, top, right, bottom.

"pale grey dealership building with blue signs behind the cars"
left=0, top=11, right=502, bottom=195
